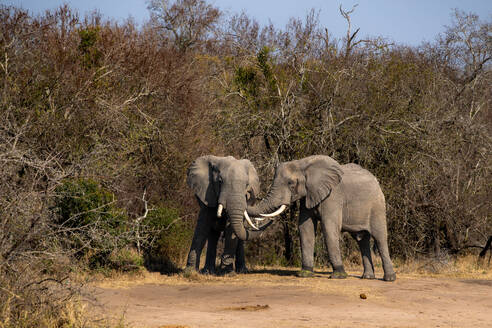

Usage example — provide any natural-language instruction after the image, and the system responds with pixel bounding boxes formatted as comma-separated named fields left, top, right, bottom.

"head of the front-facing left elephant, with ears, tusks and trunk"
left=186, top=155, right=267, bottom=240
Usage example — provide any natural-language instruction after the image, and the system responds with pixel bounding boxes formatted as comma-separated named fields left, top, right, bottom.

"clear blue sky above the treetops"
left=4, top=0, right=492, bottom=45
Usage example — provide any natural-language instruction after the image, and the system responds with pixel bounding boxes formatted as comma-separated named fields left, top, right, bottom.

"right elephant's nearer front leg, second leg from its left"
left=321, top=211, right=347, bottom=279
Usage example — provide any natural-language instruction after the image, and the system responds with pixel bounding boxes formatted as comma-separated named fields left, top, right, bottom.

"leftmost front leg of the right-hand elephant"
left=298, top=207, right=317, bottom=277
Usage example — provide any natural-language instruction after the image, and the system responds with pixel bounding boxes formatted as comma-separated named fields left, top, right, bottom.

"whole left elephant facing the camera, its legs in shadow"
left=185, top=155, right=272, bottom=274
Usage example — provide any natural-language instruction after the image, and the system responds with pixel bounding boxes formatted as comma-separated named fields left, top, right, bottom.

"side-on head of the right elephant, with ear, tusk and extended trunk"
left=247, top=155, right=343, bottom=217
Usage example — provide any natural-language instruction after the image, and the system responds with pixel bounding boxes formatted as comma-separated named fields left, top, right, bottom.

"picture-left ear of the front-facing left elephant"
left=186, top=155, right=218, bottom=207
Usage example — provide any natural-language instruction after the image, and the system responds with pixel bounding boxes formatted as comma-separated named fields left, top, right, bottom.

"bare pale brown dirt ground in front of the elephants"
left=92, top=269, right=492, bottom=328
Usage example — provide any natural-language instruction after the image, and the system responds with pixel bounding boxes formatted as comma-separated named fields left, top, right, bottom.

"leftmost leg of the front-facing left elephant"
left=186, top=207, right=211, bottom=271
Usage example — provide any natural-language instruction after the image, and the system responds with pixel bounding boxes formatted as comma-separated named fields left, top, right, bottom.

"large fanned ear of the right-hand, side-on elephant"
left=305, top=159, right=343, bottom=208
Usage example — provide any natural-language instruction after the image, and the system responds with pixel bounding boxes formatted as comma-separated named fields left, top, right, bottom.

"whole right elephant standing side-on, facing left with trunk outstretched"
left=247, top=155, right=396, bottom=281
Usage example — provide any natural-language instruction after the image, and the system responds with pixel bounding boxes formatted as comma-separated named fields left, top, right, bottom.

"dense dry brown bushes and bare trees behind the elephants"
left=0, top=0, right=492, bottom=327
